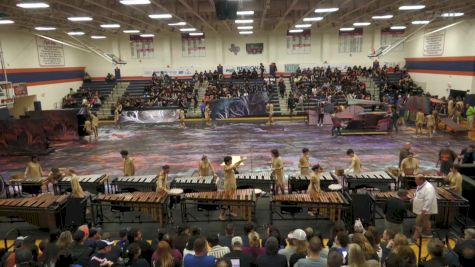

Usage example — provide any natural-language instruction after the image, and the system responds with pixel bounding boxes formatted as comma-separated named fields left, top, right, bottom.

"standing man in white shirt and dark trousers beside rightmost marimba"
left=412, top=174, right=437, bottom=241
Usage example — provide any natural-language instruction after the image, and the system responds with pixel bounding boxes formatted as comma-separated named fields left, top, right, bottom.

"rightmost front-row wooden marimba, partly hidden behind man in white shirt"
left=370, top=187, right=470, bottom=228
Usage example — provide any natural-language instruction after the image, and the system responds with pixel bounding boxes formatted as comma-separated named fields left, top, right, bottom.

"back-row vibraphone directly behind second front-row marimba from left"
left=111, top=175, right=157, bottom=193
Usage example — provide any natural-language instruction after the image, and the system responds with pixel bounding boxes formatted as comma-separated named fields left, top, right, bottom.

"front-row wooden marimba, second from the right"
left=269, top=192, right=352, bottom=224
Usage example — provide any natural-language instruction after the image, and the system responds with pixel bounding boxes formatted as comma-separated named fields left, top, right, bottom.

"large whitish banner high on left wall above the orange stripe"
left=36, top=37, right=64, bottom=66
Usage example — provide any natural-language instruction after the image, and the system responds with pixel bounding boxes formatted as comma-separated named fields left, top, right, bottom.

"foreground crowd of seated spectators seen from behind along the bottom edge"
left=1, top=221, right=475, bottom=267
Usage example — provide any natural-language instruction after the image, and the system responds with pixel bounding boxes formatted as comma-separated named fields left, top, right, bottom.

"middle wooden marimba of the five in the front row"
left=181, top=189, right=257, bottom=222
